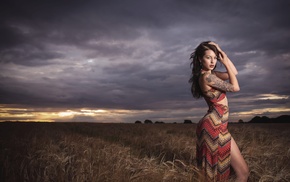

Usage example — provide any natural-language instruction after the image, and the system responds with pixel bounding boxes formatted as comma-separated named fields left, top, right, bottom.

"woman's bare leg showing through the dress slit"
left=231, top=137, right=249, bottom=182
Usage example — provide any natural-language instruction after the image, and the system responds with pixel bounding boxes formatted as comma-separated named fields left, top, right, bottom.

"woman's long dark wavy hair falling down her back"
left=188, top=41, right=219, bottom=99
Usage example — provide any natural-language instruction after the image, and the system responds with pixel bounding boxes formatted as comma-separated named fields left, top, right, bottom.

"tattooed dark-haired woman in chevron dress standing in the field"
left=189, top=41, right=249, bottom=181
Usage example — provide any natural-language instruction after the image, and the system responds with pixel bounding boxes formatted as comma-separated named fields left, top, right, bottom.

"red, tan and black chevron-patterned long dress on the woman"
left=196, top=89, right=231, bottom=181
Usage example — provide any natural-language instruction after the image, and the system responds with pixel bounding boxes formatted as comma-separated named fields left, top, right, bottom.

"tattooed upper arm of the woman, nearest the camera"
left=206, top=74, right=234, bottom=92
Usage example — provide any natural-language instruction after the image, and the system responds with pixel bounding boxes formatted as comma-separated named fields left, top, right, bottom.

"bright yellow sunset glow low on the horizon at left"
left=0, top=107, right=154, bottom=122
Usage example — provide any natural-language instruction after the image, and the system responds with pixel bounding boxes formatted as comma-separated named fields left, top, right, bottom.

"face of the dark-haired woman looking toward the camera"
left=200, top=50, right=217, bottom=71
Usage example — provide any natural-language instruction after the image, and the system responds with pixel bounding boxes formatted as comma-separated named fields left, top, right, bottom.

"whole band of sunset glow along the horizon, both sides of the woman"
left=0, top=103, right=290, bottom=123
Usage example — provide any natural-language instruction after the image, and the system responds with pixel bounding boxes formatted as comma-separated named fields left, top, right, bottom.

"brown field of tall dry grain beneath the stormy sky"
left=0, top=122, right=290, bottom=182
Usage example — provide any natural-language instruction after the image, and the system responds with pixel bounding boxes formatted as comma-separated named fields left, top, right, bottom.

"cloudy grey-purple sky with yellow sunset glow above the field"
left=0, top=0, right=290, bottom=123
